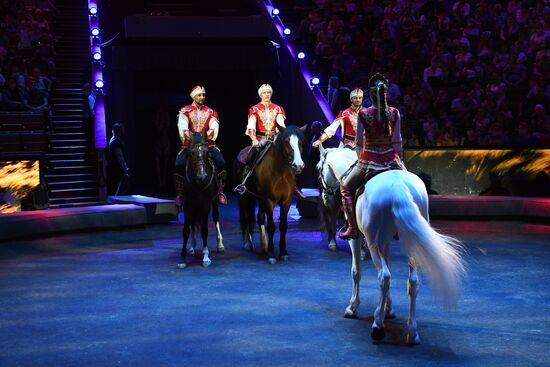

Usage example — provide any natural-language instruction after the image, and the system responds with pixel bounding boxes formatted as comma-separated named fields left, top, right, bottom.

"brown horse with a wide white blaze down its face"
left=234, top=125, right=305, bottom=264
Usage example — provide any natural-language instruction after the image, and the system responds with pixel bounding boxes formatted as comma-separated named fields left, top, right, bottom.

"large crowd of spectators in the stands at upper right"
left=292, top=0, right=550, bottom=147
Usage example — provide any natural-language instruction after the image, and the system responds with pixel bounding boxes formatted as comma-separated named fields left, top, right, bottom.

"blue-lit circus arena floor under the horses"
left=0, top=198, right=550, bottom=367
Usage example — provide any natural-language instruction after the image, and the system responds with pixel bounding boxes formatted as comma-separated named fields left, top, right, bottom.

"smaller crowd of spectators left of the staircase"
left=0, top=0, right=56, bottom=114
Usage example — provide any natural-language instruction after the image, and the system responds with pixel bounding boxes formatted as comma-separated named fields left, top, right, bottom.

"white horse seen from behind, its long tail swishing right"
left=329, top=147, right=465, bottom=344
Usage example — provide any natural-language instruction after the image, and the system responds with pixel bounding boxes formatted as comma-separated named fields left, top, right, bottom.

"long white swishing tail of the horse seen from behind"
left=392, top=181, right=466, bottom=306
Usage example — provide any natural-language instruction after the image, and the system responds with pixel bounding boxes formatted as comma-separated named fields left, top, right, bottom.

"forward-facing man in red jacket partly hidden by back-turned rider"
left=312, top=88, right=367, bottom=150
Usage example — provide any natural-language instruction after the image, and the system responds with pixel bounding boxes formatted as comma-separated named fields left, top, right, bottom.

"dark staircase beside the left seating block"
left=44, top=0, right=99, bottom=208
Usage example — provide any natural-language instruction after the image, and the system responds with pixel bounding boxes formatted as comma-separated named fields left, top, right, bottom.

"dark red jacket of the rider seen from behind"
left=358, top=107, right=402, bottom=169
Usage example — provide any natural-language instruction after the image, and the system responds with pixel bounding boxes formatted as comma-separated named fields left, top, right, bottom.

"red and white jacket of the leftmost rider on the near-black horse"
left=178, top=104, right=219, bottom=148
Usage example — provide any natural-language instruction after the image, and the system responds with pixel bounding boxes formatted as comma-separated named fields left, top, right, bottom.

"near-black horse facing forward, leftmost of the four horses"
left=178, top=133, right=218, bottom=268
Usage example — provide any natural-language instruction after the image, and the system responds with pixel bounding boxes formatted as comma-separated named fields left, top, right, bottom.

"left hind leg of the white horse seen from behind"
left=369, top=245, right=391, bottom=340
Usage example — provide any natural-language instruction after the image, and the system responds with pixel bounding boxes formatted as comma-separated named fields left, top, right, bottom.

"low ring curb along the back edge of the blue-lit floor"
left=0, top=194, right=550, bottom=241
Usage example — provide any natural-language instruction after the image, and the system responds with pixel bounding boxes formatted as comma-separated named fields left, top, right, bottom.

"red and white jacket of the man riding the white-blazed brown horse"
left=247, top=102, right=286, bottom=141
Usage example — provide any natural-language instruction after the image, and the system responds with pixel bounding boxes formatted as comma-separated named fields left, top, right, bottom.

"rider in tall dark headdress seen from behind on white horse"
left=339, top=73, right=405, bottom=240
